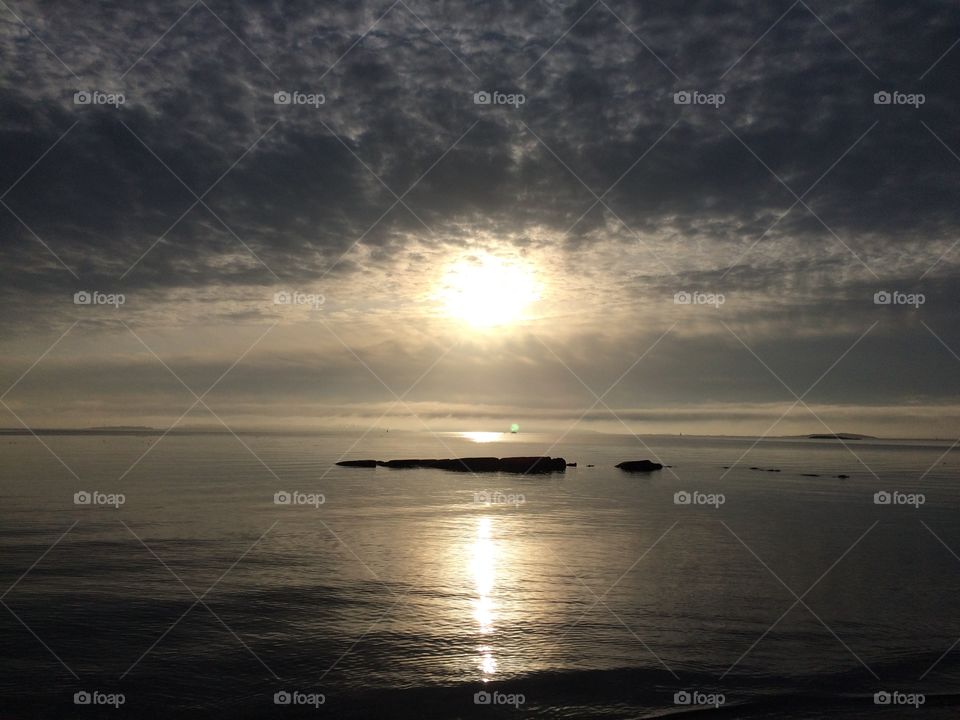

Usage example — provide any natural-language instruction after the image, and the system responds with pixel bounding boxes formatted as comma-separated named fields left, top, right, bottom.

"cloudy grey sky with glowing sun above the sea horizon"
left=0, top=0, right=960, bottom=438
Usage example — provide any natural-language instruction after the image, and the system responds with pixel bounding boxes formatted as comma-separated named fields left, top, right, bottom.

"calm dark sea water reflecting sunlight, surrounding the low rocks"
left=0, top=431, right=960, bottom=718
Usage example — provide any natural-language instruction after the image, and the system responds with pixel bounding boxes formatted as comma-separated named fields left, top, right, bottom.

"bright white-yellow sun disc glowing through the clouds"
left=438, top=255, right=540, bottom=328
